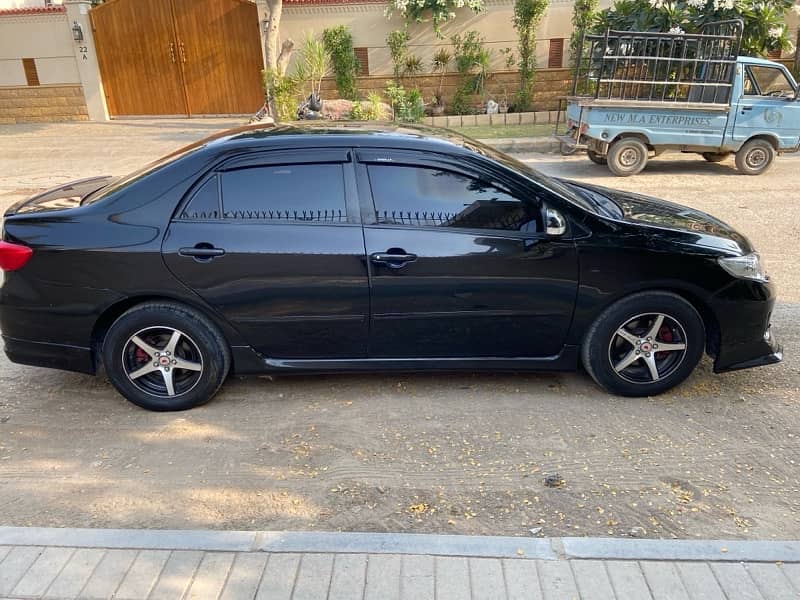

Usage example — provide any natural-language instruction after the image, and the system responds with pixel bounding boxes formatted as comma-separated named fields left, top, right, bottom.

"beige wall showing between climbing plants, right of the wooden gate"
left=281, top=0, right=611, bottom=75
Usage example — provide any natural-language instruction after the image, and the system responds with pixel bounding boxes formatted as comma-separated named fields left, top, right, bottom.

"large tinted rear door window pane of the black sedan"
left=222, top=164, right=347, bottom=223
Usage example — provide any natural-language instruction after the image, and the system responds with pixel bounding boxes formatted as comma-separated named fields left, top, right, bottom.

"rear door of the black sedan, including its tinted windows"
left=167, top=148, right=369, bottom=358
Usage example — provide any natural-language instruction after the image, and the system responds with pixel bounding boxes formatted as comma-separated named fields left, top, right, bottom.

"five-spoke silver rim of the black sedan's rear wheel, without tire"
left=122, top=327, right=203, bottom=398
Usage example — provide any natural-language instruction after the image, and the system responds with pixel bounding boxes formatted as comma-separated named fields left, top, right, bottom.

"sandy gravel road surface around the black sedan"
left=0, top=120, right=800, bottom=539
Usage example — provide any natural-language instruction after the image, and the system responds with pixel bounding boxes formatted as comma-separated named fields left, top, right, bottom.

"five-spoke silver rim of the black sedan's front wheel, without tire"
left=608, top=313, right=686, bottom=384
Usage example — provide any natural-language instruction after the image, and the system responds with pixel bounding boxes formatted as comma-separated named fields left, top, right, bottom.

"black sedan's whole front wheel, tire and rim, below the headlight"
left=581, top=292, right=706, bottom=396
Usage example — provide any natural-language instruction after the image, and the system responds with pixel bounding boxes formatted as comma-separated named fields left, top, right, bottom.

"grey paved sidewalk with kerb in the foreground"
left=0, top=527, right=800, bottom=600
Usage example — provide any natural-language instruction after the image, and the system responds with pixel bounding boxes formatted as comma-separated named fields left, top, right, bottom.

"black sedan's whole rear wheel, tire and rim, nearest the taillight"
left=102, top=302, right=231, bottom=411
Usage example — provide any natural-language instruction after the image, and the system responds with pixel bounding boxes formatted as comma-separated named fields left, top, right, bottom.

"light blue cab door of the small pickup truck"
left=733, top=64, right=800, bottom=150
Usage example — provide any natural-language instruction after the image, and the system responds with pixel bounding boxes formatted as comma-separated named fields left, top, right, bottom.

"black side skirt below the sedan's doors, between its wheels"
left=232, top=346, right=579, bottom=375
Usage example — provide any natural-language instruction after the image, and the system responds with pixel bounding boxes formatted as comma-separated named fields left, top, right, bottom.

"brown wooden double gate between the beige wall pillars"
left=91, top=0, right=264, bottom=117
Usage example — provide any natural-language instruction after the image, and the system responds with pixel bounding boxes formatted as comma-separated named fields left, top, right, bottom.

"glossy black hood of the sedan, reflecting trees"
left=570, top=182, right=753, bottom=254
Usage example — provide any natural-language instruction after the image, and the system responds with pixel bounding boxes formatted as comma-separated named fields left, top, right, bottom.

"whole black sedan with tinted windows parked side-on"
left=0, top=124, right=781, bottom=410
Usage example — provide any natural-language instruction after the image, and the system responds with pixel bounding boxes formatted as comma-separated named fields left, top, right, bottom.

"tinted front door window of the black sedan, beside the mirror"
left=367, top=165, right=539, bottom=231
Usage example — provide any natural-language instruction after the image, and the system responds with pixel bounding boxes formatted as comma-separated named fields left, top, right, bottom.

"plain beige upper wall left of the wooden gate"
left=0, top=13, right=80, bottom=87
